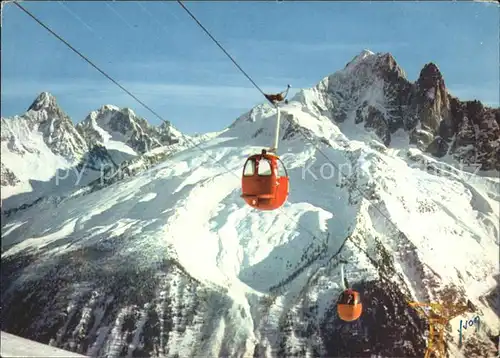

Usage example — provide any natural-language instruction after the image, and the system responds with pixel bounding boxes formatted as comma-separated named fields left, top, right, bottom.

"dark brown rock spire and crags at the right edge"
left=410, top=63, right=500, bottom=170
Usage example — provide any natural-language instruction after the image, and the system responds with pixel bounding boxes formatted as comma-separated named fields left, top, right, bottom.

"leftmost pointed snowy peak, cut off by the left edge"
left=1, top=92, right=88, bottom=209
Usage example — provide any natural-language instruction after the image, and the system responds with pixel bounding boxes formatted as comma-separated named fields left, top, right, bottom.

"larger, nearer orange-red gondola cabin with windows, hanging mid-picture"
left=241, top=149, right=289, bottom=210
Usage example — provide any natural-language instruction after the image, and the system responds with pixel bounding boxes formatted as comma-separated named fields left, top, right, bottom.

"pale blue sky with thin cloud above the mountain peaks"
left=1, top=1, right=499, bottom=133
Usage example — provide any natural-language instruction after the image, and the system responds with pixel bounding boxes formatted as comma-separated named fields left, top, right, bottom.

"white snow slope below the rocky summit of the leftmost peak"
left=0, top=112, right=105, bottom=211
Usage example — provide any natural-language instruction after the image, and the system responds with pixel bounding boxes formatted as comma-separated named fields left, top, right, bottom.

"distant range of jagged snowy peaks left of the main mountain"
left=1, top=92, right=187, bottom=211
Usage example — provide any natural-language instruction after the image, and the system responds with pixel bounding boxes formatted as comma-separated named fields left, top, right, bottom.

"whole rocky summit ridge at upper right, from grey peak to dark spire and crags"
left=314, top=51, right=500, bottom=170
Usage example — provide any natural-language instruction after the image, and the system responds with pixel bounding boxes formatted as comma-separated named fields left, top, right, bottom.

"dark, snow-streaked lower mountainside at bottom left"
left=1, top=248, right=203, bottom=357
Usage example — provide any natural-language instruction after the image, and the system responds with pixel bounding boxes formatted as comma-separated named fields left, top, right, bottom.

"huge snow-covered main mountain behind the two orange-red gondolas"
left=0, top=52, right=500, bottom=357
